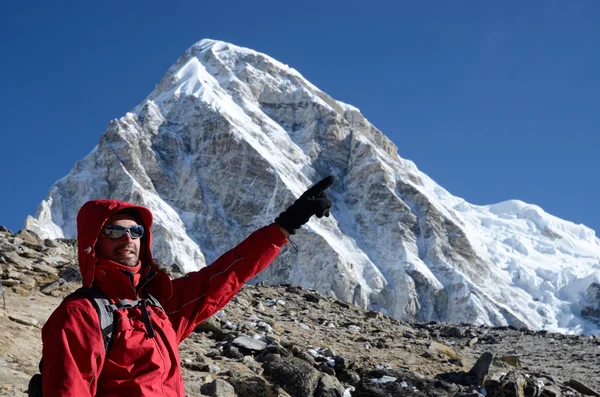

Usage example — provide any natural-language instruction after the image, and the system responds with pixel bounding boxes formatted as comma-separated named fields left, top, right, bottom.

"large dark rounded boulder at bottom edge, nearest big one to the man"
left=263, top=354, right=321, bottom=397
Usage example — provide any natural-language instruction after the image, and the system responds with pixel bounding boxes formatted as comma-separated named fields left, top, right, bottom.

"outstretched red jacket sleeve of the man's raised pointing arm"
left=163, top=224, right=287, bottom=342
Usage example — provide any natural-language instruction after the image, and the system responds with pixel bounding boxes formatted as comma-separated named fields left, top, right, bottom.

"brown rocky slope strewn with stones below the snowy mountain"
left=0, top=227, right=600, bottom=397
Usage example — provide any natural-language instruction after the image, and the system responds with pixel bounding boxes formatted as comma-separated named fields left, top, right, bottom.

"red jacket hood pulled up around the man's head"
left=77, top=200, right=158, bottom=287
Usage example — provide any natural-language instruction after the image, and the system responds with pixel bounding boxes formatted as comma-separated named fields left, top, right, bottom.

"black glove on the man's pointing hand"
left=275, top=175, right=335, bottom=234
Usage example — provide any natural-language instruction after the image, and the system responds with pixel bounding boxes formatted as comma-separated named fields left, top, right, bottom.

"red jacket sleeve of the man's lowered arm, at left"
left=42, top=299, right=104, bottom=397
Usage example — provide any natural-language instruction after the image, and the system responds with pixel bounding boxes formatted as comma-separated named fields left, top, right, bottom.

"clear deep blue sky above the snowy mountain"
left=0, top=0, right=600, bottom=232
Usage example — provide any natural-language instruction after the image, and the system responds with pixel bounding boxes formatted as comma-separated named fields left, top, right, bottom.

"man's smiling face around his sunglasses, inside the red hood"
left=96, top=214, right=141, bottom=267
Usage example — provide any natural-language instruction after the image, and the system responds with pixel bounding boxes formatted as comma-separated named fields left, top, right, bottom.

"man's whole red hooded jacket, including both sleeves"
left=42, top=200, right=287, bottom=397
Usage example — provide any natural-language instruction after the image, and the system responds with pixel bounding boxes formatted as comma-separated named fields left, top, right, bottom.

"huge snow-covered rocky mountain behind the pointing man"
left=25, top=40, right=600, bottom=333
